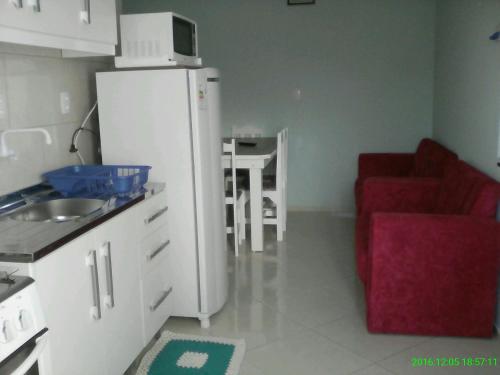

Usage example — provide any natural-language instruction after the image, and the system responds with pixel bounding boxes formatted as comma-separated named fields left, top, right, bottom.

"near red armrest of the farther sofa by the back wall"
left=358, top=153, right=415, bottom=180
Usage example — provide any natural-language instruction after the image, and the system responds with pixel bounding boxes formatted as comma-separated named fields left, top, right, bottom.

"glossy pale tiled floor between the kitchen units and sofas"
left=128, top=213, right=500, bottom=375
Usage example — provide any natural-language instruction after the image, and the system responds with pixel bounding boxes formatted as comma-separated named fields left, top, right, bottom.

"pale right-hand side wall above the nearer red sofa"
left=434, top=0, right=500, bottom=179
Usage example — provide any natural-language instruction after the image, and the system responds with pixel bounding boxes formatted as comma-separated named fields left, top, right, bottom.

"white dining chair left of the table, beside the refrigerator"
left=223, top=138, right=249, bottom=256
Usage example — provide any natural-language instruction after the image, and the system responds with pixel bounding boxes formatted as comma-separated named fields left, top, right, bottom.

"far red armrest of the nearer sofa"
left=359, top=177, right=441, bottom=215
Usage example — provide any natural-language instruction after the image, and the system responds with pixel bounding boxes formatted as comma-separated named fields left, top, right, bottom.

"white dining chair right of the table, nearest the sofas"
left=262, top=128, right=288, bottom=241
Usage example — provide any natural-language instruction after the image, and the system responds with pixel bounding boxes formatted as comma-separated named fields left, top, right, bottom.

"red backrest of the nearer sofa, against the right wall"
left=434, top=160, right=500, bottom=217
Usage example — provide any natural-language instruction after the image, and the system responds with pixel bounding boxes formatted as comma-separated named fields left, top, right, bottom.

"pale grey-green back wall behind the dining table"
left=123, top=0, right=435, bottom=212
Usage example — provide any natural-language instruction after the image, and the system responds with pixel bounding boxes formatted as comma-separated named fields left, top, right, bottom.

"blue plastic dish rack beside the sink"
left=42, top=165, right=151, bottom=197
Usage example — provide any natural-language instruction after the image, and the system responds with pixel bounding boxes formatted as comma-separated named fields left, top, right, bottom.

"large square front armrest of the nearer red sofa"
left=367, top=213, right=499, bottom=336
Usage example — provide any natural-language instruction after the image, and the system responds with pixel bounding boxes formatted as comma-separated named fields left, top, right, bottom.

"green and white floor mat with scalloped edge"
left=137, top=331, right=245, bottom=375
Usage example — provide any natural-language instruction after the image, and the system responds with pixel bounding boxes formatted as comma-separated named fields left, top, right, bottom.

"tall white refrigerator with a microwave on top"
left=97, top=68, right=228, bottom=326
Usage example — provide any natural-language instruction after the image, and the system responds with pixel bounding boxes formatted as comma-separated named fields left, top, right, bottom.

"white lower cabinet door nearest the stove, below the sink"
left=33, top=232, right=105, bottom=375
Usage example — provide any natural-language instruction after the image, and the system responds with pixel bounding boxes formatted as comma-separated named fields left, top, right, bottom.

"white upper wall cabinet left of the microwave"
left=0, top=0, right=117, bottom=57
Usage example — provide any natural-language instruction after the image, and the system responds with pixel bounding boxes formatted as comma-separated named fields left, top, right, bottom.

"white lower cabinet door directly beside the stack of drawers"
left=95, top=207, right=142, bottom=375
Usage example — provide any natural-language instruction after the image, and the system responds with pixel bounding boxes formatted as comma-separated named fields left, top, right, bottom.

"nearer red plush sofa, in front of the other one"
left=356, top=161, right=500, bottom=337
